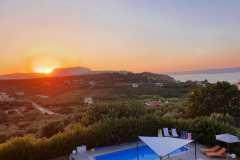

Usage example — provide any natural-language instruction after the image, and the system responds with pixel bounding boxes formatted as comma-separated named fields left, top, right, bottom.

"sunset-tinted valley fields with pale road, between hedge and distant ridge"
left=0, top=73, right=195, bottom=142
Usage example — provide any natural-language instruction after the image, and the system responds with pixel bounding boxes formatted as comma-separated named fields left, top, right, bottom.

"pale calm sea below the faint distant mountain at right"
left=170, top=72, right=240, bottom=84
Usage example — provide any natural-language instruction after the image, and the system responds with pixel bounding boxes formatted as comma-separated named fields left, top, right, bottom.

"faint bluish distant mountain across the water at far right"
left=170, top=67, right=240, bottom=75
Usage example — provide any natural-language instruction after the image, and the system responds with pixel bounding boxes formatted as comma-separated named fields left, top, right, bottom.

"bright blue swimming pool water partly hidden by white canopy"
left=95, top=146, right=189, bottom=160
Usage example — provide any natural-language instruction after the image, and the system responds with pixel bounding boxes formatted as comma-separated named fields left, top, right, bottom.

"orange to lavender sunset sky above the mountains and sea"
left=0, top=0, right=240, bottom=74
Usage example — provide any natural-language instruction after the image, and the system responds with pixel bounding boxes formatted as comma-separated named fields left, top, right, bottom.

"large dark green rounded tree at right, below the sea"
left=188, top=82, right=240, bottom=117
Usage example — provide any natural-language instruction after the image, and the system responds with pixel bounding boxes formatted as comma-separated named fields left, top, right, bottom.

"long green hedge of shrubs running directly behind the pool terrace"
left=0, top=114, right=235, bottom=160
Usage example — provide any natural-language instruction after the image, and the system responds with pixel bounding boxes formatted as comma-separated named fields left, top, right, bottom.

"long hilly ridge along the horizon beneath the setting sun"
left=0, top=67, right=175, bottom=83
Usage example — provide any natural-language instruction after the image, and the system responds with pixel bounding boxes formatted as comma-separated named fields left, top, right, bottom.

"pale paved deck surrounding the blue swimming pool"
left=72, top=143, right=224, bottom=160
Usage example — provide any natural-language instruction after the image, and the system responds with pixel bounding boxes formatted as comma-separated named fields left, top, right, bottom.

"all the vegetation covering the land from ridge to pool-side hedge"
left=0, top=73, right=240, bottom=160
